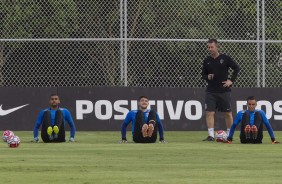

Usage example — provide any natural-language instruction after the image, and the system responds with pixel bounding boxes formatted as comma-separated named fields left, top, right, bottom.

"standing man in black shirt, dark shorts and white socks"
left=202, top=39, right=240, bottom=141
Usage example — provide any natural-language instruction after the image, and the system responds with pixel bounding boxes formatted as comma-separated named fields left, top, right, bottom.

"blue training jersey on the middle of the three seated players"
left=121, top=109, right=164, bottom=139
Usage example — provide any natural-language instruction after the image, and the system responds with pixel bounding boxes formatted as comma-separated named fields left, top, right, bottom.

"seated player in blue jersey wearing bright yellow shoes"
left=33, top=94, right=75, bottom=142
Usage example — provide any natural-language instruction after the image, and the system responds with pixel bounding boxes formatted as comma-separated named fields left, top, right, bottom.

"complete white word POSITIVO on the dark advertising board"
left=76, top=100, right=203, bottom=120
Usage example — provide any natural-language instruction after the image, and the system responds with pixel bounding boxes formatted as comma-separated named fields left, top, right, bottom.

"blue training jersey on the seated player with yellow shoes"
left=33, top=108, right=75, bottom=138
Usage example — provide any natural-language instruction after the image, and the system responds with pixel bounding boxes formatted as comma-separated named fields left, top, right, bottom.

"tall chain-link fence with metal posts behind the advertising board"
left=0, top=0, right=282, bottom=87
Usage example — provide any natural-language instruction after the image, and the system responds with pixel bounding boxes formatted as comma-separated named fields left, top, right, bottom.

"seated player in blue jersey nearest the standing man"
left=227, top=96, right=279, bottom=144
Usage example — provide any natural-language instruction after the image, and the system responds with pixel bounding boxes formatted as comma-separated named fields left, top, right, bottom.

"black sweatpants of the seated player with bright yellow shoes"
left=41, top=110, right=66, bottom=142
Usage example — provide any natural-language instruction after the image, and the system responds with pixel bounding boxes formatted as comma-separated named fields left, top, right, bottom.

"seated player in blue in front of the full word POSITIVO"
left=121, top=96, right=165, bottom=143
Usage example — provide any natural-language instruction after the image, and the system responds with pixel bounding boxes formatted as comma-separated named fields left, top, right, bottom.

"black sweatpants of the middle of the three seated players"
left=133, top=110, right=158, bottom=143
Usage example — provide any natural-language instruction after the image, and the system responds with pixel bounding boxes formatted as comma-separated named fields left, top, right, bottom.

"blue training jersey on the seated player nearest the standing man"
left=228, top=109, right=274, bottom=138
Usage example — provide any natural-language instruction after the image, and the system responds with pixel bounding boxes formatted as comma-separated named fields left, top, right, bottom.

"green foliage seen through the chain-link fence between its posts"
left=0, top=0, right=282, bottom=87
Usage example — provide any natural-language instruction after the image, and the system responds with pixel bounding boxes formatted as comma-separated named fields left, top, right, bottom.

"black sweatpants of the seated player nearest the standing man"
left=240, top=112, right=263, bottom=144
